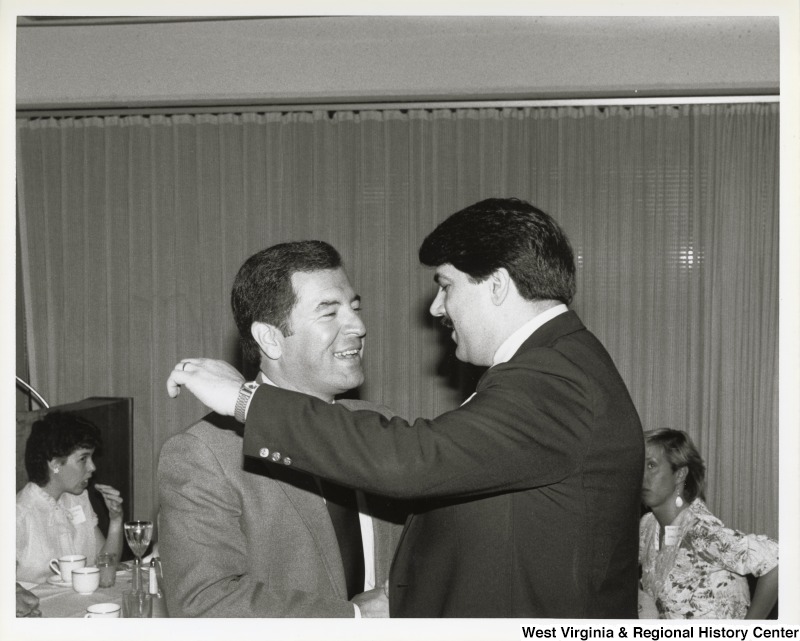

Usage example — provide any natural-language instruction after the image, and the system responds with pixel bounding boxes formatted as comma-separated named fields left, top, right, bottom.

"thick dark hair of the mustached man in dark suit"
left=419, top=198, right=575, bottom=305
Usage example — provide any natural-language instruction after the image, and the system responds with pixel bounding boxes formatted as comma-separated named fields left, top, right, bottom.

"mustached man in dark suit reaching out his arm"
left=168, top=199, right=644, bottom=618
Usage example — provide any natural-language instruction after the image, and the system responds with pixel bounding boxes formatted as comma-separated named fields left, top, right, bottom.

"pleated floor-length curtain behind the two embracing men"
left=17, top=103, right=779, bottom=536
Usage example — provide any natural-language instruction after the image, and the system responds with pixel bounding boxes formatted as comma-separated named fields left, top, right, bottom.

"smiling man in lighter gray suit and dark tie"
left=158, top=241, right=402, bottom=617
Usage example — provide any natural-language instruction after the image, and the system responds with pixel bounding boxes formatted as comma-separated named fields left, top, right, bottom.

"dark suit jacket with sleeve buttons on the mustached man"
left=239, top=312, right=644, bottom=618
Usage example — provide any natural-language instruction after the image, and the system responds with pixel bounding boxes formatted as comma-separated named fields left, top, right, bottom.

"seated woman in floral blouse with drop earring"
left=639, top=429, right=778, bottom=619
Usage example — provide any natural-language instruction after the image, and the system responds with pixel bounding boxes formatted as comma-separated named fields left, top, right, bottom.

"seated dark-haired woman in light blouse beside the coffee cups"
left=17, top=411, right=123, bottom=583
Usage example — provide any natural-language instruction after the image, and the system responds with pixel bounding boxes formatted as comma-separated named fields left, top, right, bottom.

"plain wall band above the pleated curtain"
left=16, top=11, right=780, bottom=109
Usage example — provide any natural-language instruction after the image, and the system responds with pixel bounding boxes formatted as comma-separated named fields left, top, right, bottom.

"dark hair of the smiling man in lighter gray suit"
left=231, top=240, right=342, bottom=363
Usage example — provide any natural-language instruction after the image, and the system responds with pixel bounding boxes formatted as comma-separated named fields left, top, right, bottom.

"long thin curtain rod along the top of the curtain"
left=17, top=94, right=780, bottom=118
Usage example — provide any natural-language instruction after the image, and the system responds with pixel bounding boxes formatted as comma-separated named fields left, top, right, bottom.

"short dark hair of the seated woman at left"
left=25, top=410, right=102, bottom=487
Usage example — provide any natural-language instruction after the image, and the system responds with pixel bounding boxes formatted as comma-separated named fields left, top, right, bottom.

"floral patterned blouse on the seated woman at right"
left=639, top=499, right=778, bottom=619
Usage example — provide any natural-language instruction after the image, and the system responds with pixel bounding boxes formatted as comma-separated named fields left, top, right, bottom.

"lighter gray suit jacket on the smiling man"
left=158, top=400, right=403, bottom=617
